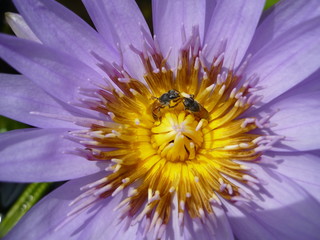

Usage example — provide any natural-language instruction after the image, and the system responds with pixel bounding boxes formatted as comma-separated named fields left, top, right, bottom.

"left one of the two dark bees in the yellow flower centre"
left=152, top=89, right=181, bottom=120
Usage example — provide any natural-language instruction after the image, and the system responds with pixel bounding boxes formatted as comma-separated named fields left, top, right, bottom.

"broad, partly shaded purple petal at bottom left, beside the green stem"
left=5, top=172, right=142, bottom=240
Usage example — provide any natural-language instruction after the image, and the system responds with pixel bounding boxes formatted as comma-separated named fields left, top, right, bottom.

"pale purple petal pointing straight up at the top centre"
left=152, top=0, right=208, bottom=67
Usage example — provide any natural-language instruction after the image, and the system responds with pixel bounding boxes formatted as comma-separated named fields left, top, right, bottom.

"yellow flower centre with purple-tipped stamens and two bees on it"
left=67, top=25, right=277, bottom=238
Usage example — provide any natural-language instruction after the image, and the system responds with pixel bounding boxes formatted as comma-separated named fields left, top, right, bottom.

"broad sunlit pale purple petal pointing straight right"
left=260, top=90, right=320, bottom=151
